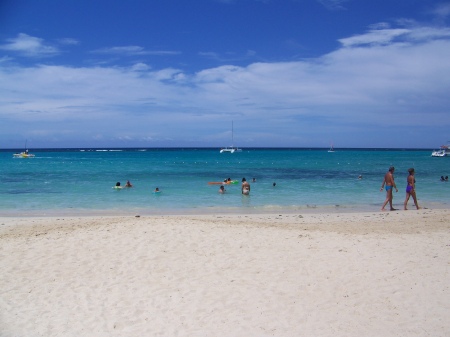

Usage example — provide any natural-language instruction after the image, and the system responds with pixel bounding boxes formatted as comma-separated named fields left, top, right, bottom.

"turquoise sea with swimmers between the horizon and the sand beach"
left=0, top=149, right=450, bottom=215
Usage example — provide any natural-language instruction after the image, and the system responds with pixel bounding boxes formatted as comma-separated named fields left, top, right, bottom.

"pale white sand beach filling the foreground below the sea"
left=0, top=209, right=450, bottom=337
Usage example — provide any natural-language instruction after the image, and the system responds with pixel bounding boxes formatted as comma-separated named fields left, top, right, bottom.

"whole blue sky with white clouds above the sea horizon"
left=0, top=0, right=450, bottom=148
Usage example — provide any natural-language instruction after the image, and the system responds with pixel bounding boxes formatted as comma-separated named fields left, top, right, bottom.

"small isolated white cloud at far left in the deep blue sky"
left=0, top=33, right=60, bottom=57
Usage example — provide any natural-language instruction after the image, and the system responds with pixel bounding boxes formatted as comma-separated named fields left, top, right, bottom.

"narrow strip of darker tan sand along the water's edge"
left=0, top=209, right=450, bottom=234
